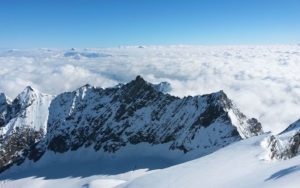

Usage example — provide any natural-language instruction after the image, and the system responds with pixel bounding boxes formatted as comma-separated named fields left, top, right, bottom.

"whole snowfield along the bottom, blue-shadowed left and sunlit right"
left=0, top=134, right=300, bottom=188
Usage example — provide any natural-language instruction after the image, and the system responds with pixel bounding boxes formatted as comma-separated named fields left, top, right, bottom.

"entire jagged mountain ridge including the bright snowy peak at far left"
left=0, top=76, right=263, bottom=171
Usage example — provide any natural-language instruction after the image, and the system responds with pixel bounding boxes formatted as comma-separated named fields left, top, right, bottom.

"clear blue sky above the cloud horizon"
left=0, top=0, right=300, bottom=48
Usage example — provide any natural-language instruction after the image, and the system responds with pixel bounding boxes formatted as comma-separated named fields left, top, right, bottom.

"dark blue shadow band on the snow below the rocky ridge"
left=0, top=157, right=176, bottom=181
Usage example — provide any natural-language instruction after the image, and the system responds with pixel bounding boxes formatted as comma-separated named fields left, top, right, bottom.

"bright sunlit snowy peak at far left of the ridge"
left=0, top=87, right=53, bottom=171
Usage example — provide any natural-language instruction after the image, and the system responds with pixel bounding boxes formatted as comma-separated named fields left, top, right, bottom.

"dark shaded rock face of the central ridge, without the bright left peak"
left=0, top=76, right=262, bottom=173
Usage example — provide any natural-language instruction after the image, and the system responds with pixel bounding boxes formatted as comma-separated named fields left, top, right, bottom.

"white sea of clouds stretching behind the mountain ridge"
left=0, top=45, right=300, bottom=132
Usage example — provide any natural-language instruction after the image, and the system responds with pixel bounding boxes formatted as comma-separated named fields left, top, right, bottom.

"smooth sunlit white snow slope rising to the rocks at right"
left=118, top=135, right=300, bottom=188
